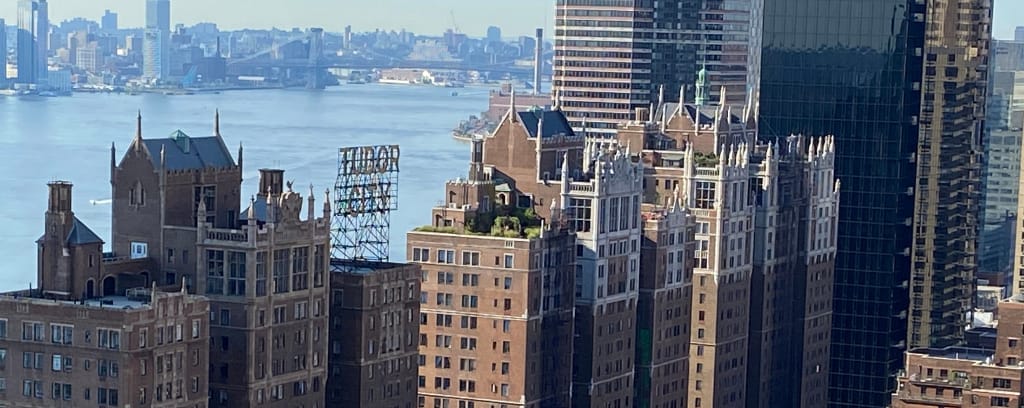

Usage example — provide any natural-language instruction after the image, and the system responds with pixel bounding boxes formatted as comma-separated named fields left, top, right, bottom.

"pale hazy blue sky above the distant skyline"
left=0, top=0, right=1024, bottom=39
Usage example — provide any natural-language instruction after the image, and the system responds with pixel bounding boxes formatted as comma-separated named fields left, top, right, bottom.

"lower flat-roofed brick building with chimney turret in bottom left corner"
left=0, top=181, right=210, bottom=408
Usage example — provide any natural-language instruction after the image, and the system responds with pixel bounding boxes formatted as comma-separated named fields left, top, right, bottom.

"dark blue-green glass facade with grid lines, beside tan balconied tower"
left=760, top=0, right=926, bottom=408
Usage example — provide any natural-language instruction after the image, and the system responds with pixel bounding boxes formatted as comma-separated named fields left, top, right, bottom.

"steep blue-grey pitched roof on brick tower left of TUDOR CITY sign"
left=142, top=130, right=234, bottom=170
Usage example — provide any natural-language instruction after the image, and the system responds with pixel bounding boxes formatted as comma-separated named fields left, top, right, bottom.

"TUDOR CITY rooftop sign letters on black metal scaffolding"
left=331, top=145, right=399, bottom=261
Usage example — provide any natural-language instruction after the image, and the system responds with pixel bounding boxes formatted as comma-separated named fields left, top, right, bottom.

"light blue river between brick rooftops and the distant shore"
left=0, top=84, right=487, bottom=291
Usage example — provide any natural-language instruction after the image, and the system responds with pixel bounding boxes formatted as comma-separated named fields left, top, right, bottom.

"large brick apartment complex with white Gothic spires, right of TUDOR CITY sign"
left=408, top=90, right=839, bottom=407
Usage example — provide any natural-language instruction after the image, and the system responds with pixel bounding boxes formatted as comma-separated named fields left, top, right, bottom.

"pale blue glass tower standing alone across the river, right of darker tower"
left=142, top=0, right=171, bottom=81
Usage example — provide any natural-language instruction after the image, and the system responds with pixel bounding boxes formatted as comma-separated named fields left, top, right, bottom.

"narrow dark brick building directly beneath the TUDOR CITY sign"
left=327, top=259, right=421, bottom=408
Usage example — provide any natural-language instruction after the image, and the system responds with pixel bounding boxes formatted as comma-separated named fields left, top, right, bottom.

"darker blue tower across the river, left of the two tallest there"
left=17, top=0, right=50, bottom=84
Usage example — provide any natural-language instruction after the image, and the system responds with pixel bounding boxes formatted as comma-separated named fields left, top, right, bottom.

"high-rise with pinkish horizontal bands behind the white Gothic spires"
left=552, top=0, right=761, bottom=135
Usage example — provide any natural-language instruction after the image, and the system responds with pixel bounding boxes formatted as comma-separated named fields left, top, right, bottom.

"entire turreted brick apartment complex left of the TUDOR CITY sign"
left=0, top=115, right=331, bottom=408
